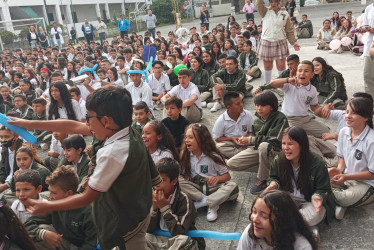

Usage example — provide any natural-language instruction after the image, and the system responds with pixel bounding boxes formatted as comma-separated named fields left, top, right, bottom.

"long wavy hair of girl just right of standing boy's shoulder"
left=147, top=121, right=179, bottom=161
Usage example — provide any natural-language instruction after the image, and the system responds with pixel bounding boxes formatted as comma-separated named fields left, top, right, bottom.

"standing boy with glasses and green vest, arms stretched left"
left=23, top=86, right=161, bottom=249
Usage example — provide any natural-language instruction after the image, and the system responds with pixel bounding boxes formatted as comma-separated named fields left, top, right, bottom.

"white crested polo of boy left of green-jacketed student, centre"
left=212, top=109, right=254, bottom=140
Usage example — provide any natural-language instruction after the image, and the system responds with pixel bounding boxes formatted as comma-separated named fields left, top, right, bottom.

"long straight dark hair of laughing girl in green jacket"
left=278, top=127, right=312, bottom=196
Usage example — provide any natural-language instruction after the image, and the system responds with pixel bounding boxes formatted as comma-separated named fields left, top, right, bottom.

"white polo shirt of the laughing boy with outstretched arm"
left=282, top=83, right=318, bottom=116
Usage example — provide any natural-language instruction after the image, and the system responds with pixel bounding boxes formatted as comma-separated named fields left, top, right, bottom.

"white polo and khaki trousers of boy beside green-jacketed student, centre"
left=212, top=110, right=254, bottom=158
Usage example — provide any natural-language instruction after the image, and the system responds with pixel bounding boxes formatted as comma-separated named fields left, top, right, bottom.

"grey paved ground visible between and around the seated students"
left=152, top=1, right=374, bottom=249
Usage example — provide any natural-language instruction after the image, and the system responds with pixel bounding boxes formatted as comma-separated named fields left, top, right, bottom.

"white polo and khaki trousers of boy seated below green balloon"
left=164, top=82, right=203, bottom=123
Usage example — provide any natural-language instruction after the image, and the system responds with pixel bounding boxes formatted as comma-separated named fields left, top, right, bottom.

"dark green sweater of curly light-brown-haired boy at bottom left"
left=25, top=206, right=96, bottom=250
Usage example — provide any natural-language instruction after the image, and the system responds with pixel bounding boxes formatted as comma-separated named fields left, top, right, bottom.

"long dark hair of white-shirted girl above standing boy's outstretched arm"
left=48, top=82, right=77, bottom=120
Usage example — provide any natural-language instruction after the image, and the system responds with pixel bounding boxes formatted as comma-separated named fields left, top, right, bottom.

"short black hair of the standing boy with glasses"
left=86, top=86, right=133, bottom=129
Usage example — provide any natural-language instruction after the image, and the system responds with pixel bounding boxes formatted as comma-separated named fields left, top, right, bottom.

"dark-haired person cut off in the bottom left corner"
left=0, top=203, right=36, bottom=250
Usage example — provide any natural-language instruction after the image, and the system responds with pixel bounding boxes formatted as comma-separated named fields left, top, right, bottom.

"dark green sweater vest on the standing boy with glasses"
left=92, top=126, right=162, bottom=249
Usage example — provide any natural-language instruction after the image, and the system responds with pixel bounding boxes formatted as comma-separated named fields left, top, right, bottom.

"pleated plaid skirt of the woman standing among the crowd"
left=256, top=39, right=290, bottom=61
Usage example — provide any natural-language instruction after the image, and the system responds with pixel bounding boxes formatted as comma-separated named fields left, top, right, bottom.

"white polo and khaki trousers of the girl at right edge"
left=334, top=125, right=374, bottom=207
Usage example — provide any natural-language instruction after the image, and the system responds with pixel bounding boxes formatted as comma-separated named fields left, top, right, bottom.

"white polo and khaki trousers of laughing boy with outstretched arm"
left=282, top=83, right=330, bottom=138
